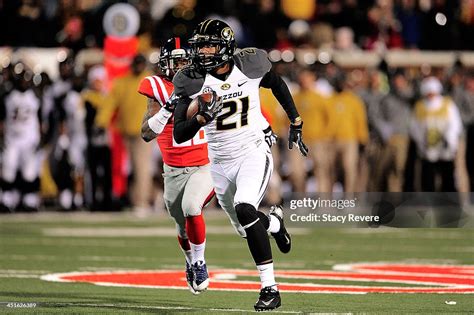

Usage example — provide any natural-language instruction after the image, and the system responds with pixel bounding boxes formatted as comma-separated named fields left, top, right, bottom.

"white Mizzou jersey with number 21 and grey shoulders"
left=175, top=48, right=271, bottom=161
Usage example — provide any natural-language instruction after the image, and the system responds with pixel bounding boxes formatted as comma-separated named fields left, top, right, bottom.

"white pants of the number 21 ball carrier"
left=211, top=141, right=273, bottom=237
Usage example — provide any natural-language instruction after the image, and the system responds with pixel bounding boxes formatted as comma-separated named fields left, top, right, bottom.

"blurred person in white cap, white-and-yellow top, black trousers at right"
left=410, top=77, right=462, bottom=192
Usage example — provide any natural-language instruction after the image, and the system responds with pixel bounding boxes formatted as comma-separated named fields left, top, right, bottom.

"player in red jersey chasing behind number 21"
left=138, top=37, right=214, bottom=294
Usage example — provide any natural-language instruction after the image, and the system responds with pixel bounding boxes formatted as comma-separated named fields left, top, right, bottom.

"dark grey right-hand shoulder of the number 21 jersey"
left=233, top=47, right=272, bottom=79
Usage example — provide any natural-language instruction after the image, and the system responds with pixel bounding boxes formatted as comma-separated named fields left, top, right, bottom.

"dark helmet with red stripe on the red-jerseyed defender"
left=158, top=37, right=191, bottom=80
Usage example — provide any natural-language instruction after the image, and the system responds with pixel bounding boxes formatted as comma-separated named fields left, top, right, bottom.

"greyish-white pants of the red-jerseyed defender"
left=163, top=164, right=214, bottom=239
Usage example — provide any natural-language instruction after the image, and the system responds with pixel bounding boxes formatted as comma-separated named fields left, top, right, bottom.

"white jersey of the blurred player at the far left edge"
left=5, top=90, right=41, bottom=144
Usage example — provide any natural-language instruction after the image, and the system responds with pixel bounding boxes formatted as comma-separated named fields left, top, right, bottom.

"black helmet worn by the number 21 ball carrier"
left=189, top=19, right=236, bottom=71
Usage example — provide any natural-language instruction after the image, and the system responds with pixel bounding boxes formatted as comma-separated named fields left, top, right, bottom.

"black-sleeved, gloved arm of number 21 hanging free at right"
left=260, top=70, right=308, bottom=156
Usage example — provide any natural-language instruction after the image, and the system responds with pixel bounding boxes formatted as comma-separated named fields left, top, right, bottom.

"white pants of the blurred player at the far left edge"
left=2, top=141, right=42, bottom=183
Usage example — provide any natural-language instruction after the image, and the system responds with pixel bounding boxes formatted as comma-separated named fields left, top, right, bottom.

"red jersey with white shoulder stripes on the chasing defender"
left=138, top=76, right=209, bottom=167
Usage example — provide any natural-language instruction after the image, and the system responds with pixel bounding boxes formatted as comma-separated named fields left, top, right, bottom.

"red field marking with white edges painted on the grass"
left=41, top=263, right=474, bottom=294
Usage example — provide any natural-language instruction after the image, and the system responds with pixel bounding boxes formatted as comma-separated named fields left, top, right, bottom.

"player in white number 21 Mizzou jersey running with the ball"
left=173, top=19, right=308, bottom=311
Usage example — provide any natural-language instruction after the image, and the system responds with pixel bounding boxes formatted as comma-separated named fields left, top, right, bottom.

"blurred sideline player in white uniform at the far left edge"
left=2, top=63, right=41, bottom=211
